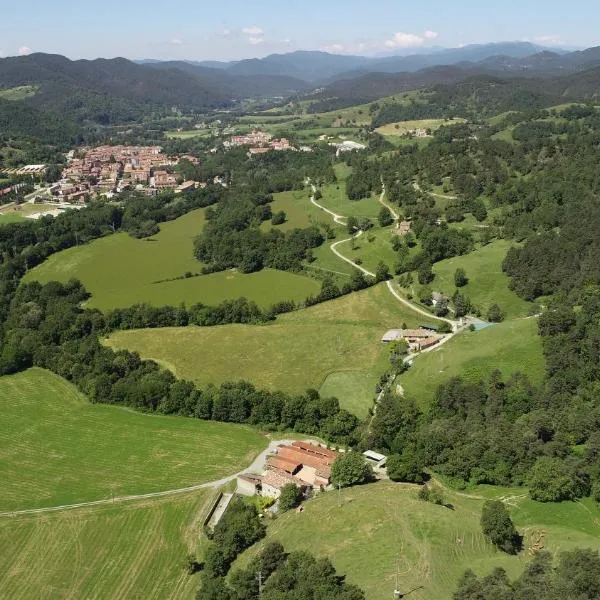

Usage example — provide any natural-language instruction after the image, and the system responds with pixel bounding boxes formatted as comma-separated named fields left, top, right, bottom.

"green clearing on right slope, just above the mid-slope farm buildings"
left=431, top=240, right=531, bottom=319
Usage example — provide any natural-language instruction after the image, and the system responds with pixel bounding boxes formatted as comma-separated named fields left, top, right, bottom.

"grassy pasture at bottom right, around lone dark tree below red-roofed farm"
left=235, top=482, right=600, bottom=600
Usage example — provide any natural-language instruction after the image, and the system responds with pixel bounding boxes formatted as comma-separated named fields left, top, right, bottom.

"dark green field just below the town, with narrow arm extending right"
left=25, top=209, right=320, bottom=310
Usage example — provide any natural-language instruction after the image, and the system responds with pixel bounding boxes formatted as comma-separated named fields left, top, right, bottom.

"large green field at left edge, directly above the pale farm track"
left=0, top=369, right=266, bottom=508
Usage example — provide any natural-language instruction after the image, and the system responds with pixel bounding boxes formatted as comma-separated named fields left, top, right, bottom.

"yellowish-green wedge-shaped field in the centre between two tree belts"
left=107, top=285, right=419, bottom=416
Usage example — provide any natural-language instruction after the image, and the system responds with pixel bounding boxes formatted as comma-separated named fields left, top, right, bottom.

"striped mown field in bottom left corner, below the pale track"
left=0, top=490, right=214, bottom=600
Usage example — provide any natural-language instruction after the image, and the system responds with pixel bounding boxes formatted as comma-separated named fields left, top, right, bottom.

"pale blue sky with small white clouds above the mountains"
left=0, top=0, right=600, bottom=60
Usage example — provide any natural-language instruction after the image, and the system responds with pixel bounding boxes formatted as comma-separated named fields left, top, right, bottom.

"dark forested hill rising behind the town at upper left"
left=0, top=53, right=298, bottom=124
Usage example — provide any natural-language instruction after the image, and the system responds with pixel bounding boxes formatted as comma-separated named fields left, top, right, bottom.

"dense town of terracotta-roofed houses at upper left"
left=51, top=146, right=197, bottom=203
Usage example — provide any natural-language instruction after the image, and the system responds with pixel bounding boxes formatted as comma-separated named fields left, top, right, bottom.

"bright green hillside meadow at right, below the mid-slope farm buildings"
left=399, top=318, right=544, bottom=408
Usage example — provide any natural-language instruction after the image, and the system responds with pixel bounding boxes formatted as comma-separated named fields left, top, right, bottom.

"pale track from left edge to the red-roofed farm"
left=0, top=440, right=293, bottom=517
